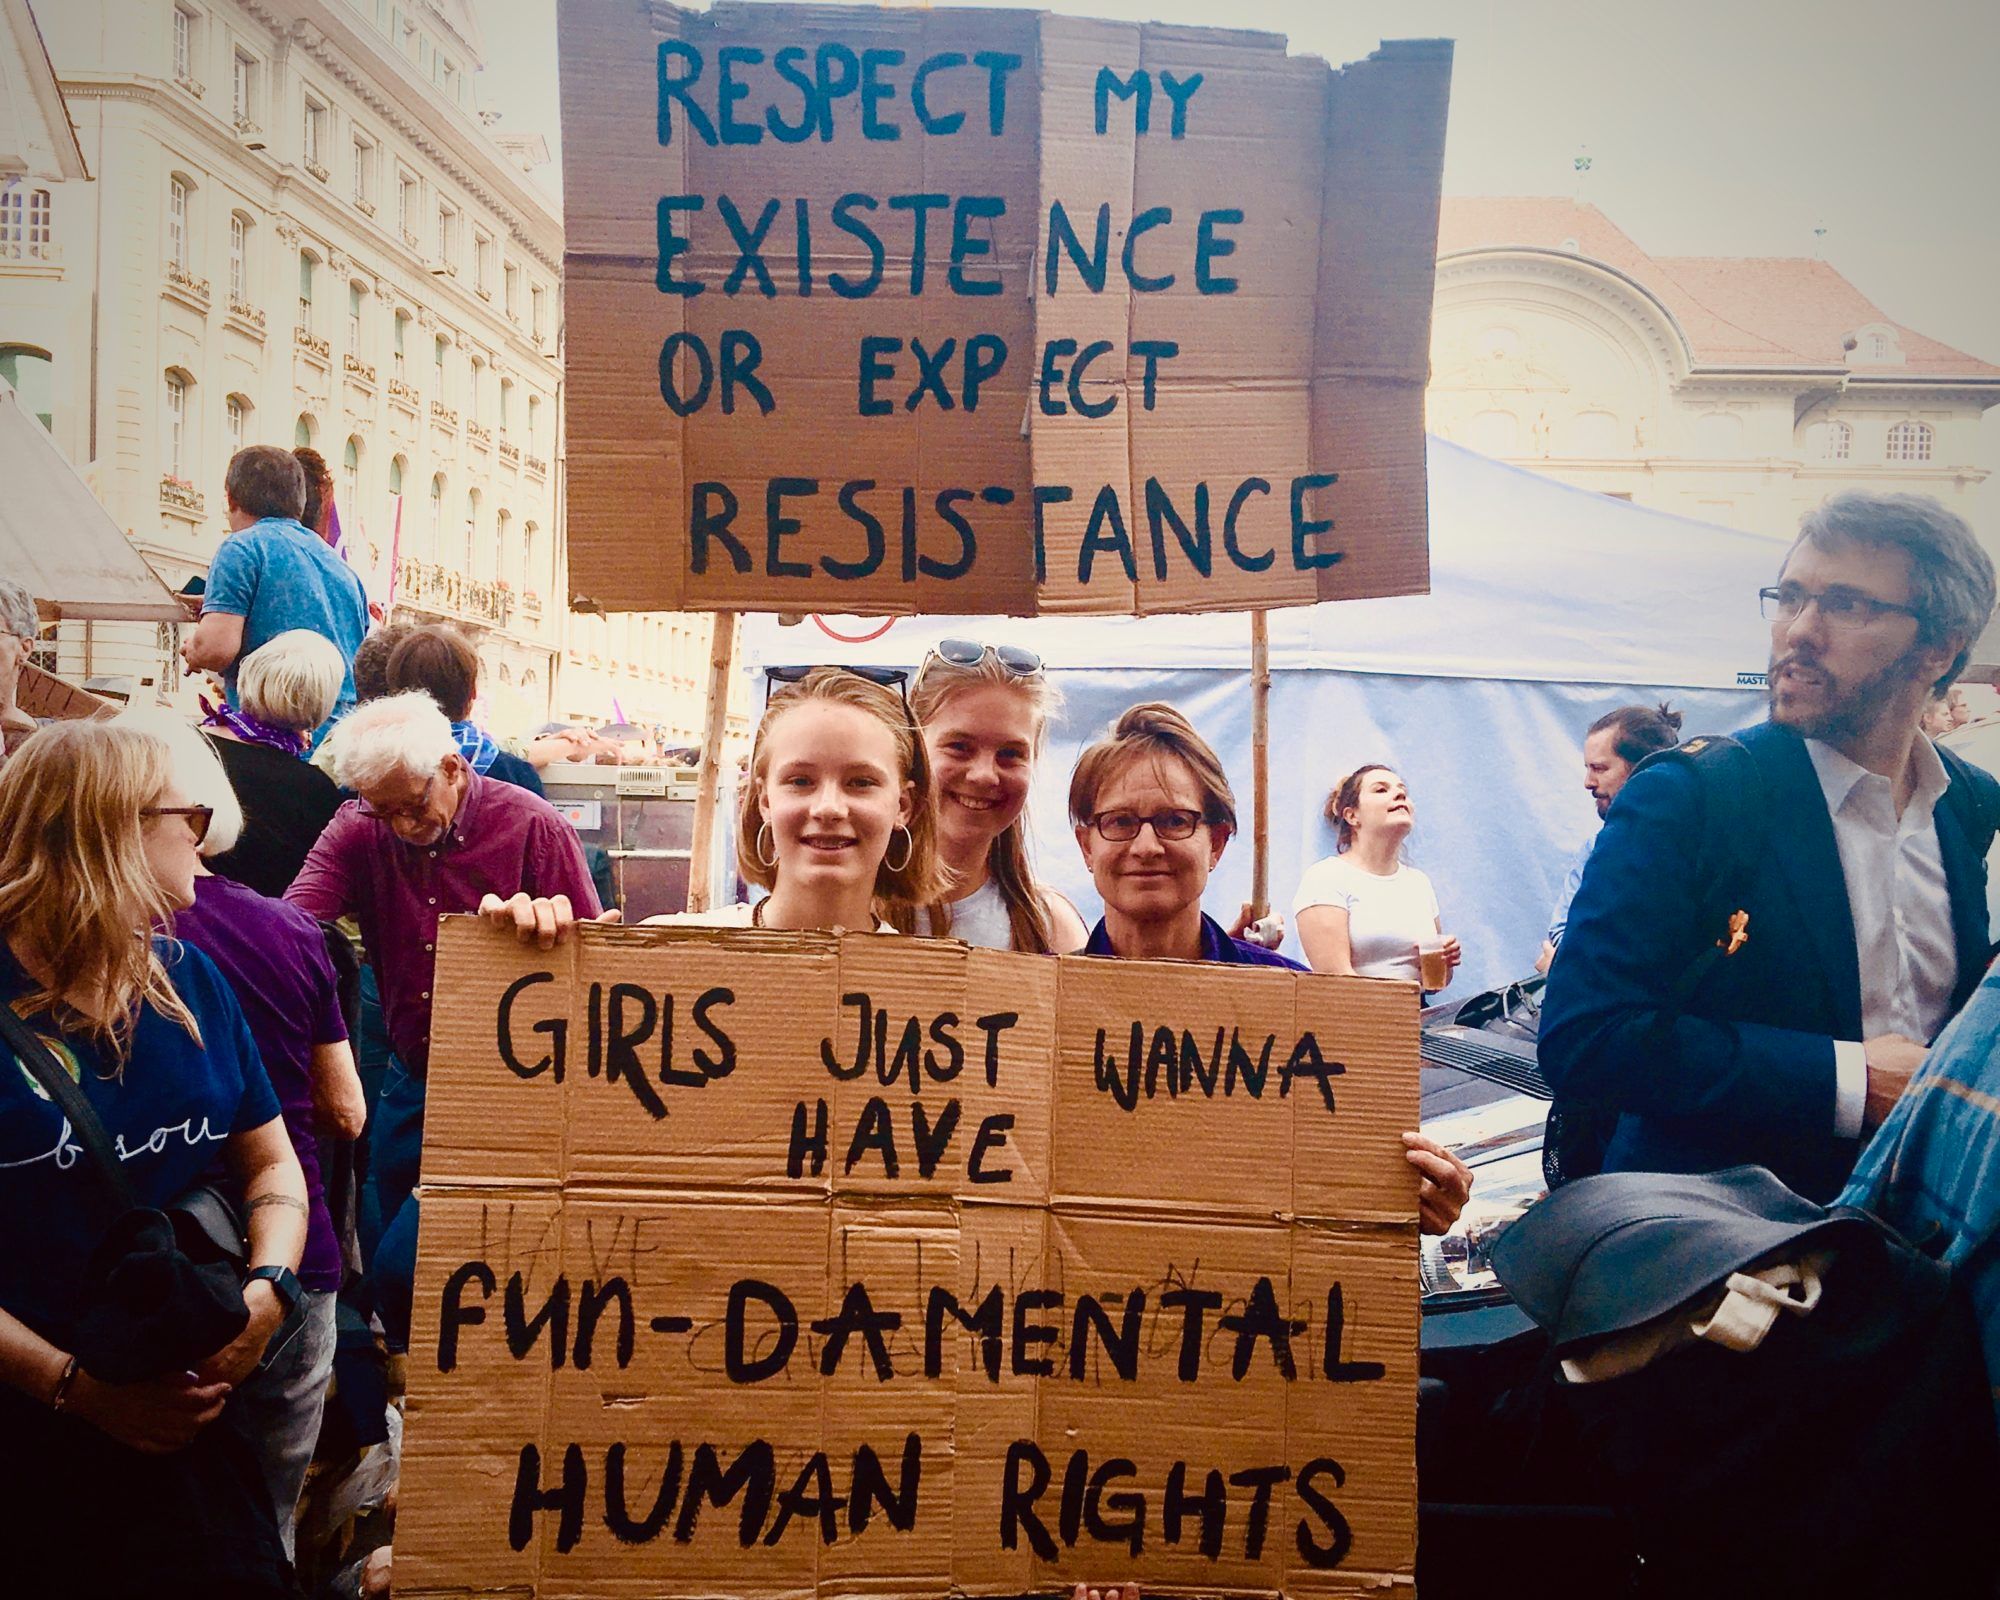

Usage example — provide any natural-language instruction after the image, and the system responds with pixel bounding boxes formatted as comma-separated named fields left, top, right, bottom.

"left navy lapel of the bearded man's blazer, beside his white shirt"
left=1738, top=722, right=1862, bottom=1038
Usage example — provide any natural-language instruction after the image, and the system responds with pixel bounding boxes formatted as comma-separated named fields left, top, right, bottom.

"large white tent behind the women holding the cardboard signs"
left=744, top=438, right=1784, bottom=994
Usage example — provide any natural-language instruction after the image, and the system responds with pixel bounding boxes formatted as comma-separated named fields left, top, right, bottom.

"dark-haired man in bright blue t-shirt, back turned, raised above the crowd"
left=180, top=444, right=368, bottom=742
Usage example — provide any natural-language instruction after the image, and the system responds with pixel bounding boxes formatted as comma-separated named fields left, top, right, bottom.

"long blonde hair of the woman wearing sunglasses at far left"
left=0, top=722, right=202, bottom=1066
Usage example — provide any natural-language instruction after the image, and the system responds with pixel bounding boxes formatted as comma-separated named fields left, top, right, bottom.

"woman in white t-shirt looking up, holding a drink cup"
left=1292, top=766, right=1460, bottom=984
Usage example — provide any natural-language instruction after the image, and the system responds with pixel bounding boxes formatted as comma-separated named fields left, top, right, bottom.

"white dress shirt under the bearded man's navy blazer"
left=1806, top=734, right=1958, bottom=1138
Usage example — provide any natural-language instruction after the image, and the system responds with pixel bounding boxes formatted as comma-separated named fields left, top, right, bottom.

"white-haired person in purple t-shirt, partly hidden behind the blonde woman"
left=148, top=718, right=366, bottom=1554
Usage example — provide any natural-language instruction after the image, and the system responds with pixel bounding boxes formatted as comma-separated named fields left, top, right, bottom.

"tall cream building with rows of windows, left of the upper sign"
left=0, top=0, right=744, bottom=734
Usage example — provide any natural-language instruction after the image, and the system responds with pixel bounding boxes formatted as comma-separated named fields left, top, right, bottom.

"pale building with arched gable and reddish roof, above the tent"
left=1428, top=198, right=2000, bottom=538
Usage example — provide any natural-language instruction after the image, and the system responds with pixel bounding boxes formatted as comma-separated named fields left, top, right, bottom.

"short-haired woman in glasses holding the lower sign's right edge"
left=1070, top=702, right=1472, bottom=1234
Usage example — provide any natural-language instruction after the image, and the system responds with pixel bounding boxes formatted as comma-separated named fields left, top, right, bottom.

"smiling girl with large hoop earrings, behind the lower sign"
left=646, top=666, right=944, bottom=932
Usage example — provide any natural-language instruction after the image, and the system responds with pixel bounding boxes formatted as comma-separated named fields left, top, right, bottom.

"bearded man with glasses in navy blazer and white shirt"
left=1540, top=494, right=2000, bottom=1200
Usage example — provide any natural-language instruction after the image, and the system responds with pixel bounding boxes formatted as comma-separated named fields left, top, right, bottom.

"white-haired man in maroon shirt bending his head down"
left=284, top=690, right=616, bottom=1350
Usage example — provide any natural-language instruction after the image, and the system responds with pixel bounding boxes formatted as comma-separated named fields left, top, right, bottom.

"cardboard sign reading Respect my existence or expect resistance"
left=558, top=0, right=1450, bottom=614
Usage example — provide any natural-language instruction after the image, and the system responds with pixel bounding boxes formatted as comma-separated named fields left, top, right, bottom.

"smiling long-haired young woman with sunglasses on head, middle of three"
left=910, top=638, right=1084, bottom=956
